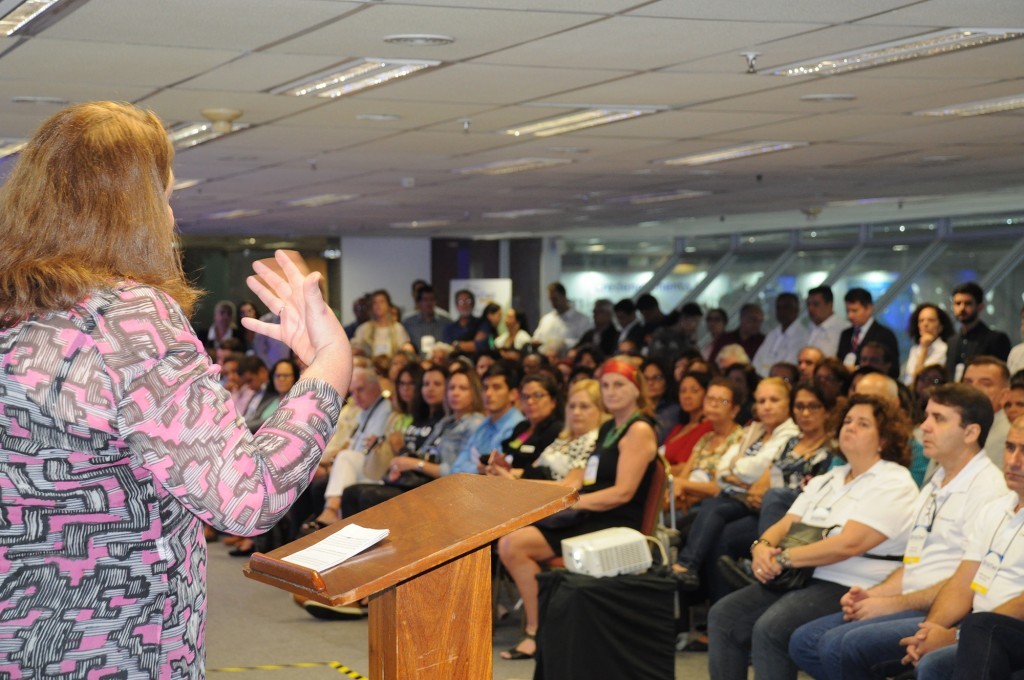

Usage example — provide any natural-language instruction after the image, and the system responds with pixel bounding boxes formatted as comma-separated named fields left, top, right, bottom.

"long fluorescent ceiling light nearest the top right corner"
left=769, top=29, right=1024, bottom=76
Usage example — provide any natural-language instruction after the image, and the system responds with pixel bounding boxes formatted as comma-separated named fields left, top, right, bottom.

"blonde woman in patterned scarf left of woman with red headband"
left=486, top=378, right=608, bottom=483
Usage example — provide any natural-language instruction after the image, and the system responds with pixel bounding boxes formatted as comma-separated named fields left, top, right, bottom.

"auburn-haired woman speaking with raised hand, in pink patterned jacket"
left=0, top=102, right=351, bottom=678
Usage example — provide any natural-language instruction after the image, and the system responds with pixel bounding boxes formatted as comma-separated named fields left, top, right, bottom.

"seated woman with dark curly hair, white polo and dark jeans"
left=708, top=394, right=918, bottom=680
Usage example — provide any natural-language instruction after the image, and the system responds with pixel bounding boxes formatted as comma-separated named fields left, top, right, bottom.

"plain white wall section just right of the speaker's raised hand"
left=341, top=238, right=430, bottom=324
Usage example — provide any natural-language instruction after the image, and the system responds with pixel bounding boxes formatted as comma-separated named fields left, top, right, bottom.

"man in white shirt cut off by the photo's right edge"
left=901, top=418, right=1024, bottom=680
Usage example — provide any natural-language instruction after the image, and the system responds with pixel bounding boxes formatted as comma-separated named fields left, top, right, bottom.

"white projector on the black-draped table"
left=562, top=526, right=651, bottom=577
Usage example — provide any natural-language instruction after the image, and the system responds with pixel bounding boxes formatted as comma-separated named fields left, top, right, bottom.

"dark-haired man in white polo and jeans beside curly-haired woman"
left=790, top=384, right=1007, bottom=678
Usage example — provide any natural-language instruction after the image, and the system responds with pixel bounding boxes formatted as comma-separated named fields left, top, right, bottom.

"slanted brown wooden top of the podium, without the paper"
left=243, top=474, right=578, bottom=604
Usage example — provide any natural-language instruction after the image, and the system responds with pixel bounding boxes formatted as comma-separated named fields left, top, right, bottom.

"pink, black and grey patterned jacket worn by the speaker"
left=0, top=283, right=341, bottom=678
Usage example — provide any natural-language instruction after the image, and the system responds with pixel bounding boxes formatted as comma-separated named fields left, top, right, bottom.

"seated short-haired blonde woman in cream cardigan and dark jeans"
left=672, top=378, right=800, bottom=591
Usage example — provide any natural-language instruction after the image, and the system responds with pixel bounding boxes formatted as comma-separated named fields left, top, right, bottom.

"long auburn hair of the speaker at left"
left=0, top=101, right=200, bottom=327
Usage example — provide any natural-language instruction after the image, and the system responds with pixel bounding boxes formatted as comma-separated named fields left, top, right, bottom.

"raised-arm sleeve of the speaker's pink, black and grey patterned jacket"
left=95, top=286, right=341, bottom=535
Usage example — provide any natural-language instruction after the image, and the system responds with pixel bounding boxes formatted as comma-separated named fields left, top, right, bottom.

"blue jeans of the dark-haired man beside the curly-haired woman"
left=790, top=610, right=926, bottom=680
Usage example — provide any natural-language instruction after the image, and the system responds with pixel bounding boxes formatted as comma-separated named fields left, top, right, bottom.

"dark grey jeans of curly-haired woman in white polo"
left=708, top=579, right=849, bottom=680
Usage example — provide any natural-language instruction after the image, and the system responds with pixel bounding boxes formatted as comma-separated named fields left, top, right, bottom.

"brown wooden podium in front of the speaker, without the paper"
left=243, top=474, right=578, bottom=680
